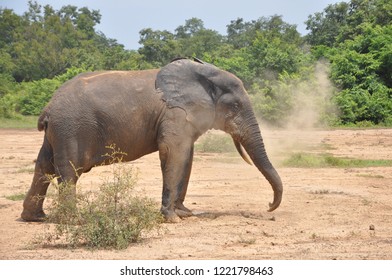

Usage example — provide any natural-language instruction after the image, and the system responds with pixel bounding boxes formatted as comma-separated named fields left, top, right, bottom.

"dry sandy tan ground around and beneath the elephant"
left=0, top=129, right=392, bottom=259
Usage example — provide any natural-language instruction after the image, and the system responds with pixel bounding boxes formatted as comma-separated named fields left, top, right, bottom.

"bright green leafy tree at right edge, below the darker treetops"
left=329, top=24, right=392, bottom=124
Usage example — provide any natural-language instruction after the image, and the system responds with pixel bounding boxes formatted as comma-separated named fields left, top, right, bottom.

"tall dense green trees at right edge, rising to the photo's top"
left=306, top=0, right=392, bottom=126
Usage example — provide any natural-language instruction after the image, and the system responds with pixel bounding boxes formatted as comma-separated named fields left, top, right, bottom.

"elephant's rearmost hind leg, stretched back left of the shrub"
left=21, top=137, right=55, bottom=221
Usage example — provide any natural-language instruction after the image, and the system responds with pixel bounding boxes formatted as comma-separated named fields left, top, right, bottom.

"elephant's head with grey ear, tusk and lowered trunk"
left=156, top=59, right=283, bottom=211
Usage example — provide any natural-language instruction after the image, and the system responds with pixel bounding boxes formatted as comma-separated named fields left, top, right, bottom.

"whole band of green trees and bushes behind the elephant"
left=0, top=0, right=392, bottom=126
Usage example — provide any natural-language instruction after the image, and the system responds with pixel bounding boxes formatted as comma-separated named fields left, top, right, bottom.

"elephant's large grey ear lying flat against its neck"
left=155, top=59, right=219, bottom=133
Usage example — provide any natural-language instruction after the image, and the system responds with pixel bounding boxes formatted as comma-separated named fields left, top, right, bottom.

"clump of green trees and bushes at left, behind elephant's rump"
left=0, top=1, right=134, bottom=117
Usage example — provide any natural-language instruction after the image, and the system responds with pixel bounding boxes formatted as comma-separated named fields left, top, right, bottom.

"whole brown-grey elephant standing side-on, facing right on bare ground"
left=21, top=58, right=283, bottom=222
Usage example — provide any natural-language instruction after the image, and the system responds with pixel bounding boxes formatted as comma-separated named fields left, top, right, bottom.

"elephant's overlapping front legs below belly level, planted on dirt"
left=159, top=142, right=193, bottom=223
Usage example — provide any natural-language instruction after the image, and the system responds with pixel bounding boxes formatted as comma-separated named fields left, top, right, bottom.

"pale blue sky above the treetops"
left=0, top=0, right=347, bottom=50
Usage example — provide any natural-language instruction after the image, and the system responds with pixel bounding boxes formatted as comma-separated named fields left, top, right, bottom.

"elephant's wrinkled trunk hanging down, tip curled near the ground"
left=239, top=114, right=283, bottom=212
